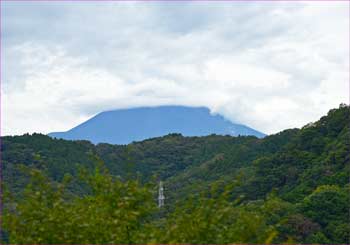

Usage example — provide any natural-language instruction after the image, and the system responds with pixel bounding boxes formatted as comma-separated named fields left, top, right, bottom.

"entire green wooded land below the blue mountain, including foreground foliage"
left=1, top=105, right=350, bottom=244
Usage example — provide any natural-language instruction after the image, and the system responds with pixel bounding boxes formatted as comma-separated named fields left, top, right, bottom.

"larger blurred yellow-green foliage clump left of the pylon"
left=4, top=168, right=155, bottom=244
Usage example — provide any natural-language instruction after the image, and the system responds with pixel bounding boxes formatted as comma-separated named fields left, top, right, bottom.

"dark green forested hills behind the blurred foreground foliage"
left=1, top=105, right=350, bottom=244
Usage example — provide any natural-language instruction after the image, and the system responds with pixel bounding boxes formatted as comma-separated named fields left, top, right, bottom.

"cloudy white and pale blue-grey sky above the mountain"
left=1, top=1, right=350, bottom=135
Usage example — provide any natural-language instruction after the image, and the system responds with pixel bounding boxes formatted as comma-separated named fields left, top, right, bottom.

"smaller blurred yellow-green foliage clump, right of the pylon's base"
left=161, top=185, right=276, bottom=244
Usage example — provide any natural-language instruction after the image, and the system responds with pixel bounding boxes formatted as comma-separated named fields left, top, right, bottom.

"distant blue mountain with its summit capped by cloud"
left=49, top=106, right=265, bottom=144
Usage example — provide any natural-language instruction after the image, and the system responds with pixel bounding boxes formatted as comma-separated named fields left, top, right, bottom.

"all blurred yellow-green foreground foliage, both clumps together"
left=4, top=167, right=276, bottom=244
